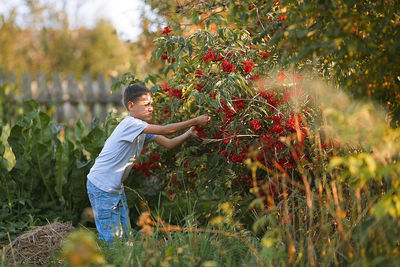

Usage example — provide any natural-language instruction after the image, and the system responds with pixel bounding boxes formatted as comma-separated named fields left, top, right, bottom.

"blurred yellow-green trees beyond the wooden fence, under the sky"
left=0, top=0, right=135, bottom=77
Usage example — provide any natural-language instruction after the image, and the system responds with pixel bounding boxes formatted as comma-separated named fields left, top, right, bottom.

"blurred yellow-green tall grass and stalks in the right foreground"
left=247, top=80, right=400, bottom=266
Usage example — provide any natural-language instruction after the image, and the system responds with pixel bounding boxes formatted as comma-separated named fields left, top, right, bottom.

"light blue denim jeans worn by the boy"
left=86, top=180, right=130, bottom=244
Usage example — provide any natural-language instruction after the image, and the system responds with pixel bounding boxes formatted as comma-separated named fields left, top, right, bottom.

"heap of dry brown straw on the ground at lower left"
left=5, top=222, right=74, bottom=266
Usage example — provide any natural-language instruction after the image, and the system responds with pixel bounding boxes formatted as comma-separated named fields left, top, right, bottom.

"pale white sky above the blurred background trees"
left=0, top=0, right=155, bottom=41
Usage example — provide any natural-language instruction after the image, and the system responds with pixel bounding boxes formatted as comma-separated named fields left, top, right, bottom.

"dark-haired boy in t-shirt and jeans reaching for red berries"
left=87, top=84, right=210, bottom=244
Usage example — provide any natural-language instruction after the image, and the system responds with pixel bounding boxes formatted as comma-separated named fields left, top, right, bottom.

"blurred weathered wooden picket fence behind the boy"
left=0, top=72, right=123, bottom=122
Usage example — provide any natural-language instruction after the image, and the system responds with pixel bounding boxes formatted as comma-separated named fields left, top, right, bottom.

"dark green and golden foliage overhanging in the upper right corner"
left=147, top=0, right=400, bottom=125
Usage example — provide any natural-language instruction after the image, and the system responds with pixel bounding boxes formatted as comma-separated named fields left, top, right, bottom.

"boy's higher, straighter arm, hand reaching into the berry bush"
left=143, top=115, right=210, bottom=136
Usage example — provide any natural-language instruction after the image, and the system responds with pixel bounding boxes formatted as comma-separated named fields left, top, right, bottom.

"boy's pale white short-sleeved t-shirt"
left=87, top=116, right=157, bottom=193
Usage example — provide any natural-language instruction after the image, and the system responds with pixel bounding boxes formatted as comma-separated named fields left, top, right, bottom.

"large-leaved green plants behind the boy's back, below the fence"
left=0, top=100, right=117, bottom=239
